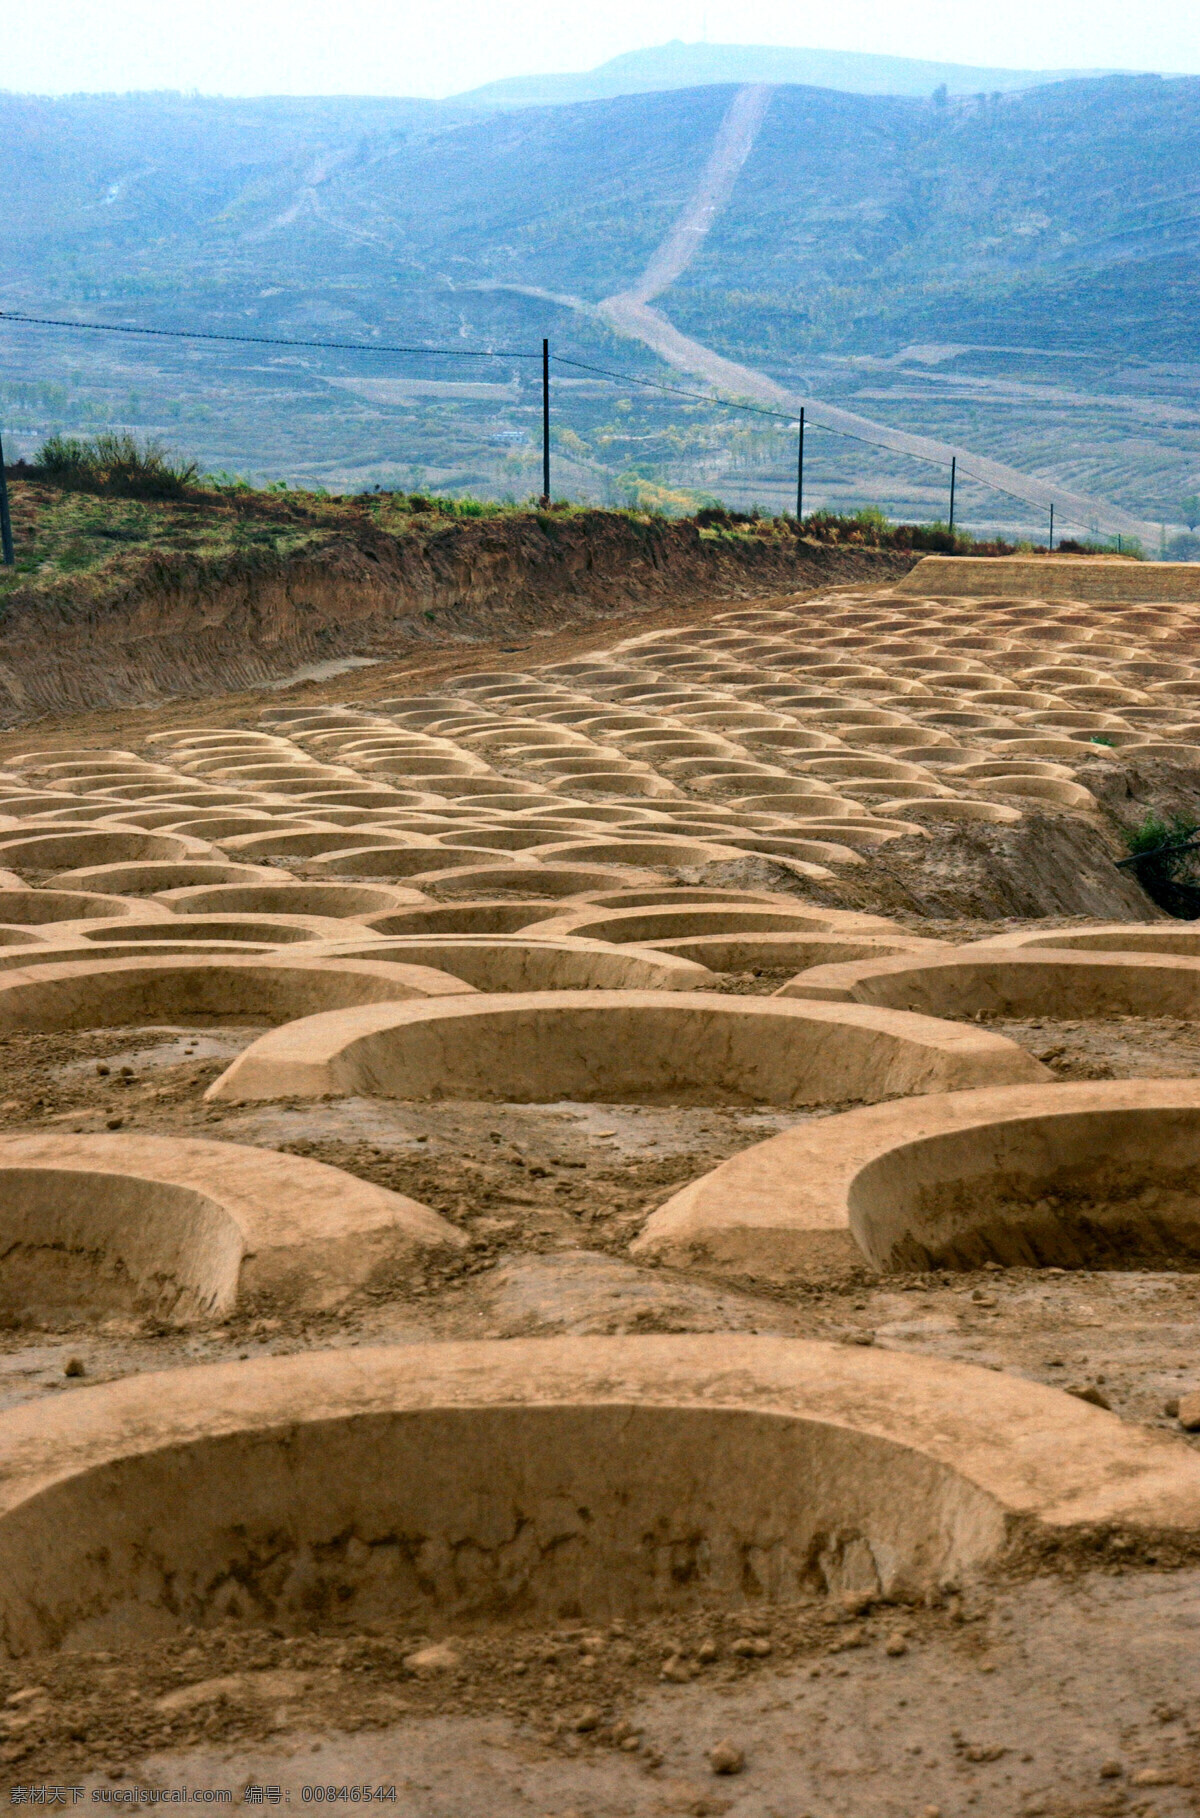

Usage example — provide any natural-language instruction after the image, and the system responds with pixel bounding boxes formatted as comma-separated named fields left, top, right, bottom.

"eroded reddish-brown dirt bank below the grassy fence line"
left=0, top=513, right=916, bottom=725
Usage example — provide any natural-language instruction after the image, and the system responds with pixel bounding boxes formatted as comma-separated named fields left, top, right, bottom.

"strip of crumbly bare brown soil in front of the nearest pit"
left=18, top=1560, right=1200, bottom=1818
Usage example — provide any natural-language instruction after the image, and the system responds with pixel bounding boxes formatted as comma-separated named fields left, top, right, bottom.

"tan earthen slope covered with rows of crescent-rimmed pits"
left=0, top=558, right=1200, bottom=1818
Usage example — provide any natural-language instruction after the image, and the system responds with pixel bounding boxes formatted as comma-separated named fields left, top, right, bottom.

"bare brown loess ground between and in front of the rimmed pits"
left=0, top=559, right=1200, bottom=1818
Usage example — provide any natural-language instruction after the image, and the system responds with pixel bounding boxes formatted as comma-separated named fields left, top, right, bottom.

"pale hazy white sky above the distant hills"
left=9, top=0, right=1200, bottom=95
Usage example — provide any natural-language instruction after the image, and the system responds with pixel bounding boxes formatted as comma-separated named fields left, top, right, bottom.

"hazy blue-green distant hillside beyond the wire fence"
left=0, top=76, right=1200, bottom=527
